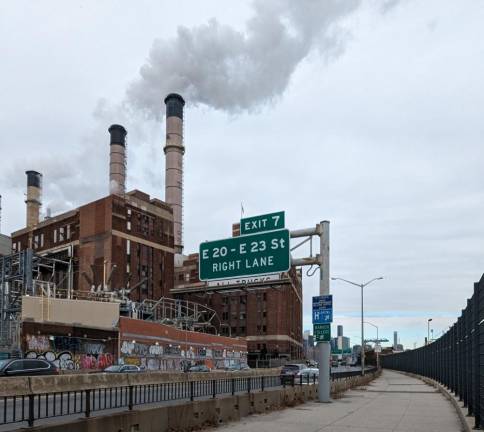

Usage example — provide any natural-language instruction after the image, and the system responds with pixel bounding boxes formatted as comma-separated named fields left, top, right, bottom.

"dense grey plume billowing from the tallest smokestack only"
left=127, top=0, right=360, bottom=118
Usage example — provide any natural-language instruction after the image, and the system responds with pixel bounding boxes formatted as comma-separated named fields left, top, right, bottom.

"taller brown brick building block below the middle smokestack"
left=12, top=190, right=174, bottom=302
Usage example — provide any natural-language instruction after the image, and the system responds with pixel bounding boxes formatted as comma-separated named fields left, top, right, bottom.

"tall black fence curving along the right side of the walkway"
left=380, top=275, right=484, bottom=428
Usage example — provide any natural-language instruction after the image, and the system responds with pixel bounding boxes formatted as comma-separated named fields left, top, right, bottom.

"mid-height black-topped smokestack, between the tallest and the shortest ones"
left=108, top=125, right=127, bottom=195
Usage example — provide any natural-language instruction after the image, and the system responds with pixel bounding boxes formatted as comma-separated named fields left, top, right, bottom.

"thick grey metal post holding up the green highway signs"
left=318, top=221, right=331, bottom=403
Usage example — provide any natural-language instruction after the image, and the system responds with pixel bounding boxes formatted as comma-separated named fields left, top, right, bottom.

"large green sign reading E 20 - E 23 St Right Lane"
left=198, top=229, right=291, bottom=281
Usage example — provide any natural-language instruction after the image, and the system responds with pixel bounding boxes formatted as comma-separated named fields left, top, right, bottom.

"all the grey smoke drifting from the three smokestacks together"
left=5, top=0, right=398, bottom=223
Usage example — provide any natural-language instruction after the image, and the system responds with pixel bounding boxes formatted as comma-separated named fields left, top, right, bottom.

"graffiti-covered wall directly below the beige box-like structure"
left=25, top=335, right=115, bottom=370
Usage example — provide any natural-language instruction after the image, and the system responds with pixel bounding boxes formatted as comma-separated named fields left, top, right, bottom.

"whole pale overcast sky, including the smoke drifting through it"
left=0, top=0, right=484, bottom=347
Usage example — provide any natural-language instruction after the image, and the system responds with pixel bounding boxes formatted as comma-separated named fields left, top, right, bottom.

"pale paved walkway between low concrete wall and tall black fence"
left=211, top=371, right=462, bottom=432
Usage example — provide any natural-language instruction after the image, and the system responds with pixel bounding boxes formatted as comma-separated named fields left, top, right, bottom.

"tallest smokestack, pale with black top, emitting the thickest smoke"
left=164, top=93, right=185, bottom=254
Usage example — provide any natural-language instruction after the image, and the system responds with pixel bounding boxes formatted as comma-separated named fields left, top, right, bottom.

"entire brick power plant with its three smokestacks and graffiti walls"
left=0, top=94, right=302, bottom=370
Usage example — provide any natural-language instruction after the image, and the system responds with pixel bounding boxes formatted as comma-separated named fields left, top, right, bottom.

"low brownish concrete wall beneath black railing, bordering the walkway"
left=30, top=373, right=378, bottom=432
